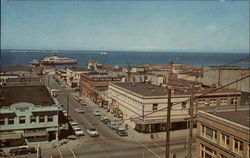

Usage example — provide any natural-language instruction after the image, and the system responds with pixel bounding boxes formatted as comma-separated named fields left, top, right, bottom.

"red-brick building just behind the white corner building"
left=80, top=72, right=122, bottom=101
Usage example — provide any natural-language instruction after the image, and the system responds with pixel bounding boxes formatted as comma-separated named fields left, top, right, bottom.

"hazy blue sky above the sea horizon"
left=1, top=0, right=249, bottom=52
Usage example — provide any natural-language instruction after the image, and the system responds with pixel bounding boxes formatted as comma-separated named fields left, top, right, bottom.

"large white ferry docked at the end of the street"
left=41, top=55, right=77, bottom=65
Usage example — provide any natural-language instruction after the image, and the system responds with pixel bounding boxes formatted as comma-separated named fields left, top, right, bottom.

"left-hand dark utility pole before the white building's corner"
left=165, top=88, right=172, bottom=158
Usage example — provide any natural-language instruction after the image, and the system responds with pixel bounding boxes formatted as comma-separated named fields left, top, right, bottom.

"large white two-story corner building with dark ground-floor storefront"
left=108, top=82, right=189, bottom=133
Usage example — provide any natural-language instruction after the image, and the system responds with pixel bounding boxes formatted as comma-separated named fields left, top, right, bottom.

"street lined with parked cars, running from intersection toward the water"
left=27, top=74, right=190, bottom=158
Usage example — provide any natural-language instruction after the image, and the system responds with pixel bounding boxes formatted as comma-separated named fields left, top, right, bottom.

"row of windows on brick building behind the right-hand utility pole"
left=197, top=98, right=238, bottom=106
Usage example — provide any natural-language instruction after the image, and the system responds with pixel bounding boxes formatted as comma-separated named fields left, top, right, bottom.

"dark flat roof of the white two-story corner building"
left=112, top=82, right=170, bottom=96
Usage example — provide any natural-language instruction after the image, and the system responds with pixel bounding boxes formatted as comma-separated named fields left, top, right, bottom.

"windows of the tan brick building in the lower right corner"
left=201, top=125, right=243, bottom=155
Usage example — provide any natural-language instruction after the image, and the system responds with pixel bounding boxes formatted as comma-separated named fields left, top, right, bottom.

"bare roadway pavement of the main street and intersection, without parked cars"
left=42, top=75, right=191, bottom=158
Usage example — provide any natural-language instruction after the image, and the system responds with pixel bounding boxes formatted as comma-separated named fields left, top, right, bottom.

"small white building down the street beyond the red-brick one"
left=66, top=67, right=90, bottom=88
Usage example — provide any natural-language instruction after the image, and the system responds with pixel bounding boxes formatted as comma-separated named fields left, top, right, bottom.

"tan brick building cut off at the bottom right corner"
left=196, top=106, right=250, bottom=158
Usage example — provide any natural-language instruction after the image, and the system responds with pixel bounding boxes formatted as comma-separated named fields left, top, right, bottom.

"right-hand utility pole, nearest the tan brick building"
left=187, top=85, right=194, bottom=158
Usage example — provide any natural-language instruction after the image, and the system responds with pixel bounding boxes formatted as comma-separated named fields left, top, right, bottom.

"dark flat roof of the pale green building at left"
left=0, top=85, right=54, bottom=107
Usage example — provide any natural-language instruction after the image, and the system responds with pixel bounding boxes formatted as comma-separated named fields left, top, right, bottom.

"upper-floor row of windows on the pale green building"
left=0, top=115, right=53, bottom=125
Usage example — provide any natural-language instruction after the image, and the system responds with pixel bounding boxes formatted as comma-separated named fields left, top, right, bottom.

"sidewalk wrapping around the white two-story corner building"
left=71, top=93, right=196, bottom=141
